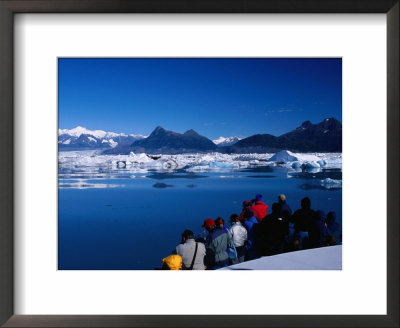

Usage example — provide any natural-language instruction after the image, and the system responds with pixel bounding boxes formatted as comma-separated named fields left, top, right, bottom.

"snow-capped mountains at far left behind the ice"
left=58, top=126, right=145, bottom=150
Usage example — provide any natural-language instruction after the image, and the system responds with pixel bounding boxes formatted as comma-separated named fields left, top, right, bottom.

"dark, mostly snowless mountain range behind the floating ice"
left=104, top=118, right=342, bottom=154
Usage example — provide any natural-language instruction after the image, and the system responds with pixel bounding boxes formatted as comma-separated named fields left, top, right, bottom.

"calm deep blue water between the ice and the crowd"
left=58, top=167, right=342, bottom=270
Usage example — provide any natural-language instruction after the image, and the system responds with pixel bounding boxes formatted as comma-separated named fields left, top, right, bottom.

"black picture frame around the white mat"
left=0, top=0, right=400, bottom=327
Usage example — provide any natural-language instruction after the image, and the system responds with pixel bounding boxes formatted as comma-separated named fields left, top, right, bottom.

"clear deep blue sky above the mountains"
left=58, top=58, right=342, bottom=139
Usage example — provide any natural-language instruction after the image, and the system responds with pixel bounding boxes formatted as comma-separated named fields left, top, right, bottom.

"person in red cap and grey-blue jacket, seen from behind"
left=202, top=219, right=231, bottom=270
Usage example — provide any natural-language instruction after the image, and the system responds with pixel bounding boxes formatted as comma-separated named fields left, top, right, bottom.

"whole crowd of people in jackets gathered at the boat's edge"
left=162, top=194, right=342, bottom=270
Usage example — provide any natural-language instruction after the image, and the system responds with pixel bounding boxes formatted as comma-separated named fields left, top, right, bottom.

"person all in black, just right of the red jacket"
left=260, top=203, right=289, bottom=256
